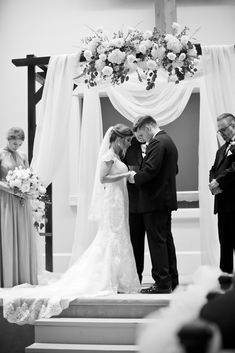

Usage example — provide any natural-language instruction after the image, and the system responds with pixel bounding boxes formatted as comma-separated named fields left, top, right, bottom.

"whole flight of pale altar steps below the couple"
left=26, top=294, right=168, bottom=353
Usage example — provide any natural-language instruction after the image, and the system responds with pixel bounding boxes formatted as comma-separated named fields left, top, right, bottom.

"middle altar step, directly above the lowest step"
left=35, top=318, right=152, bottom=345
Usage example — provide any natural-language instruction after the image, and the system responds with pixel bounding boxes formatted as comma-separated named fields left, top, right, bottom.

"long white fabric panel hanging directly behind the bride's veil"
left=70, top=88, right=103, bottom=264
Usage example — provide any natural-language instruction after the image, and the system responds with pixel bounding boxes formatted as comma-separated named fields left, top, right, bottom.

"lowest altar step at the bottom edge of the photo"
left=25, top=343, right=138, bottom=353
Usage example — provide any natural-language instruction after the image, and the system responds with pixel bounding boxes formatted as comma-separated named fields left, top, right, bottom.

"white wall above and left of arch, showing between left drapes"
left=0, top=0, right=235, bottom=269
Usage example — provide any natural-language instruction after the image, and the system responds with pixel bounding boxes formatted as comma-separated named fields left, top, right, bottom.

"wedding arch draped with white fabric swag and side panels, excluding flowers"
left=13, top=45, right=235, bottom=269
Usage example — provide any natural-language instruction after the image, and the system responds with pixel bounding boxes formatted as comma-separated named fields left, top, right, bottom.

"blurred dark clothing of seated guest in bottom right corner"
left=200, top=289, right=235, bottom=349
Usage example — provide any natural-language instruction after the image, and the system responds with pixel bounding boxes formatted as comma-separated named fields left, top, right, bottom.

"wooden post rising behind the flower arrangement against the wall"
left=155, top=0, right=177, bottom=33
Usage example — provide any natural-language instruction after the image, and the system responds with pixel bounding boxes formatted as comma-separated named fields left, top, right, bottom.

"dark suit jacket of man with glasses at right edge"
left=209, top=144, right=235, bottom=213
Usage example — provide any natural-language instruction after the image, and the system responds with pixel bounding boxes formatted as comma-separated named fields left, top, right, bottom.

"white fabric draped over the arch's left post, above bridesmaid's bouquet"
left=31, top=55, right=76, bottom=185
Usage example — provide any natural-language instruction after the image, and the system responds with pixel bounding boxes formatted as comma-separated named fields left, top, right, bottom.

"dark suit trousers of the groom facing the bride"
left=144, top=210, right=179, bottom=289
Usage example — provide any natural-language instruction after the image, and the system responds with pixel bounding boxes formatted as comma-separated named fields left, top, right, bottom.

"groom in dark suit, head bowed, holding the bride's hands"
left=130, top=116, right=178, bottom=293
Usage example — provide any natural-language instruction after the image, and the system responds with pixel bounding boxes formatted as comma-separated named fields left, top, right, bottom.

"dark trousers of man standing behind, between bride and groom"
left=129, top=212, right=145, bottom=283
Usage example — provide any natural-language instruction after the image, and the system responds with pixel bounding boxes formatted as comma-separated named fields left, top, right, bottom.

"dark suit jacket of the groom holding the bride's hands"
left=134, top=130, right=178, bottom=213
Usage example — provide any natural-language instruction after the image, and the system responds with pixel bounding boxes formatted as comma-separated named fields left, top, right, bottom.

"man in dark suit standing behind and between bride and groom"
left=124, top=137, right=146, bottom=283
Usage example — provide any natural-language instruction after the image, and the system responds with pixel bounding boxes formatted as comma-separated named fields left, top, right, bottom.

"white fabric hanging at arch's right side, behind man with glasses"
left=199, top=45, right=235, bottom=266
